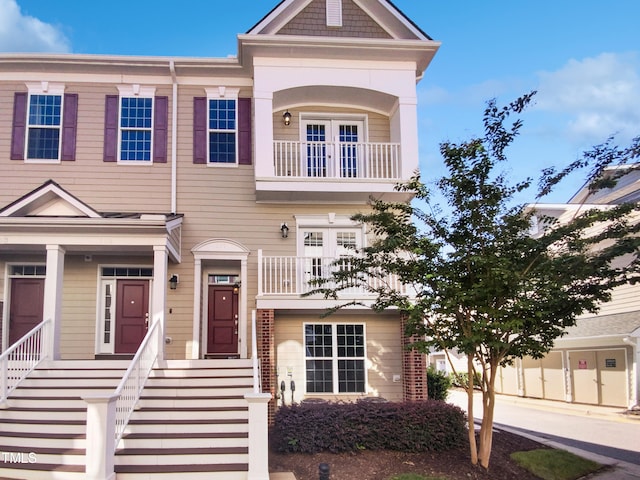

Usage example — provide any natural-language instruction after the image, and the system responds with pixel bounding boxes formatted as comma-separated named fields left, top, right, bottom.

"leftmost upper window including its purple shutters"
left=11, top=82, right=78, bottom=162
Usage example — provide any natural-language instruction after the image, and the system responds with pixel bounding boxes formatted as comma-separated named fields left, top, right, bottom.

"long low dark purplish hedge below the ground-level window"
left=271, top=400, right=465, bottom=453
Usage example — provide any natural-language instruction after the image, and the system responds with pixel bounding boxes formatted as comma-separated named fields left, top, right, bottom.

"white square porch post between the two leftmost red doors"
left=42, top=245, right=65, bottom=360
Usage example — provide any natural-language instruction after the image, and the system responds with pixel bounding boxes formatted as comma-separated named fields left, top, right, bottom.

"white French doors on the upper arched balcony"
left=303, top=120, right=364, bottom=178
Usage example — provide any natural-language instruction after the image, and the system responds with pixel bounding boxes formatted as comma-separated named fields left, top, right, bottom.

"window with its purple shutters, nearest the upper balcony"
left=193, top=87, right=252, bottom=166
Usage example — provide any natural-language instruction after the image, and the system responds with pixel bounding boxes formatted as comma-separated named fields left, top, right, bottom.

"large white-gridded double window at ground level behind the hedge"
left=304, top=323, right=366, bottom=393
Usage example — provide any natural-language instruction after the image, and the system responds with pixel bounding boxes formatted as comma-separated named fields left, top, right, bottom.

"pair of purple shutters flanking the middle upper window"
left=103, top=95, right=169, bottom=163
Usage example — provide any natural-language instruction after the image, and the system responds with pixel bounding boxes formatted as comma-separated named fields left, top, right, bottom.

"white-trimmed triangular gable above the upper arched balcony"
left=247, top=0, right=432, bottom=40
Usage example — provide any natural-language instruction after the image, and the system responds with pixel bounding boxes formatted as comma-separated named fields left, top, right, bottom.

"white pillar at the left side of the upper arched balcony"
left=253, top=90, right=275, bottom=178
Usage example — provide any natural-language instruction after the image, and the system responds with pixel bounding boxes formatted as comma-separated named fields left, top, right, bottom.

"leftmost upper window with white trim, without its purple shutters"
left=26, top=82, right=64, bottom=161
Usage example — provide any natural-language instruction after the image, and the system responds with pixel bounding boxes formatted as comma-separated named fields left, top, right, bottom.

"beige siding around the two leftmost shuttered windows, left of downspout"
left=0, top=82, right=171, bottom=212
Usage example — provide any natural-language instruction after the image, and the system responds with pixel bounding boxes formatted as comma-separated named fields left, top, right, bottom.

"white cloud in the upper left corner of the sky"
left=0, top=0, right=71, bottom=53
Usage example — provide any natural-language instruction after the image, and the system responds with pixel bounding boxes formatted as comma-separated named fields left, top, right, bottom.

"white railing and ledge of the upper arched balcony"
left=256, top=140, right=406, bottom=201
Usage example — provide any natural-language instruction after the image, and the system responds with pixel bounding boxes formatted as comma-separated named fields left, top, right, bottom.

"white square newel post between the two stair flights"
left=83, top=395, right=118, bottom=480
